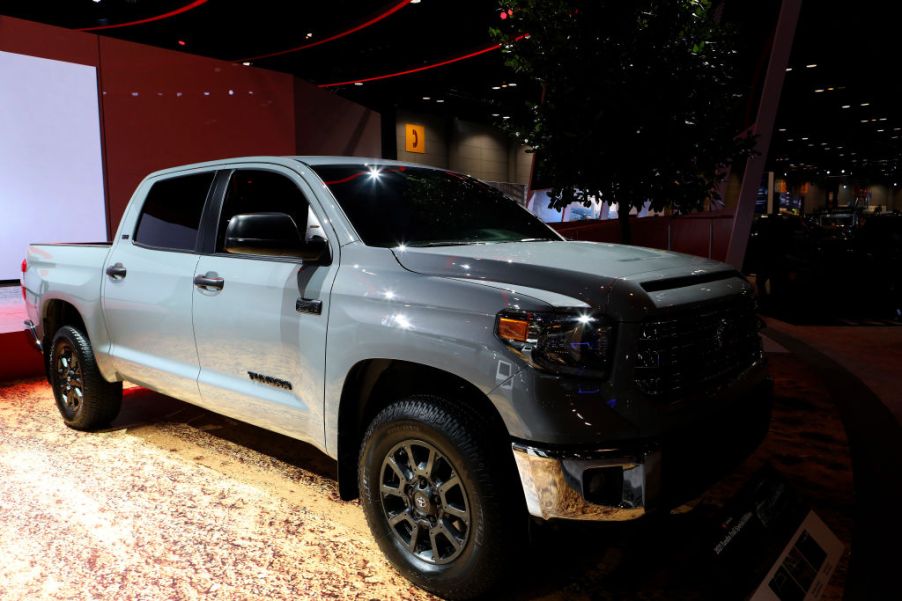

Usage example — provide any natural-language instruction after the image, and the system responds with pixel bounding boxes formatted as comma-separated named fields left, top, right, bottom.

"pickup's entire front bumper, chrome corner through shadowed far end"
left=512, top=379, right=773, bottom=521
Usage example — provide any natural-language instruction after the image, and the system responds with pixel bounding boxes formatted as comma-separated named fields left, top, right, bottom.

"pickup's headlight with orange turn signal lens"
left=495, top=309, right=614, bottom=378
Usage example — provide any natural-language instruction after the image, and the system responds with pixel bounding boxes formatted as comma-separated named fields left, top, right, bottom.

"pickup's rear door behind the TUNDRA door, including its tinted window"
left=101, top=171, right=215, bottom=403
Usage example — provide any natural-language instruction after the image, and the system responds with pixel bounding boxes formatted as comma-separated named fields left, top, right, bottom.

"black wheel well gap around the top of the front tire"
left=337, top=359, right=508, bottom=500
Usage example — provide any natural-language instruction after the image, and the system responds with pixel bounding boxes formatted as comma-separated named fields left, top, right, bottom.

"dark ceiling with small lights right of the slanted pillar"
left=768, top=0, right=902, bottom=183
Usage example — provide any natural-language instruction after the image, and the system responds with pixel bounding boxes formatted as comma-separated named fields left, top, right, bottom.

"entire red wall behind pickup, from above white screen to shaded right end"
left=0, top=16, right=382, bottom=233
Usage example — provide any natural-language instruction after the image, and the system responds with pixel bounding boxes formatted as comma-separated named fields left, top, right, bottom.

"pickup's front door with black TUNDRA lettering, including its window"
left=194, top=165, right=338, bottom=446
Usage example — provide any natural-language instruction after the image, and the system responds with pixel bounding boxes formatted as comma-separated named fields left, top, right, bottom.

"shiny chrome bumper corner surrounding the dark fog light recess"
left=511, top=442, right=660, bottom=522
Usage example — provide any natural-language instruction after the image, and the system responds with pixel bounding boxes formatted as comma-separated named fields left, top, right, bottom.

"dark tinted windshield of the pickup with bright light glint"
left=312, top=165, right=560, bottom=247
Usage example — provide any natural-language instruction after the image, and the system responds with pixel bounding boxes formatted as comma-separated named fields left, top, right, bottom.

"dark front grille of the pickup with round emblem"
left=635, top=296, right=762, bottom=399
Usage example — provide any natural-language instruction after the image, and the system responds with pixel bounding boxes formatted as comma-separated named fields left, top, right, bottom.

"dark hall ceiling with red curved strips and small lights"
left=0, top=0, right=902, bottom=182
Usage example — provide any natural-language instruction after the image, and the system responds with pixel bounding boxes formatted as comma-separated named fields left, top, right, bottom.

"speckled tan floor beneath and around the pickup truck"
left=0, top=354, right=853, bottom=601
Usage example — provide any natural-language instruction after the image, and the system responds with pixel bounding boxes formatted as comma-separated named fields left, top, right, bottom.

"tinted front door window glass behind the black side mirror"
left=216, top=169, right=318, bottom=256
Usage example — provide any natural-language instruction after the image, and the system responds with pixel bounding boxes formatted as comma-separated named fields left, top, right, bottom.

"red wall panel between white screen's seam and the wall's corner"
left=100, top=37, right=295, bottom=224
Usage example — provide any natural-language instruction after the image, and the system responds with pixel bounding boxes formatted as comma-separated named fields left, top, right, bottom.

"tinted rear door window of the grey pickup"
left=135, top=172, right=214, bottom=250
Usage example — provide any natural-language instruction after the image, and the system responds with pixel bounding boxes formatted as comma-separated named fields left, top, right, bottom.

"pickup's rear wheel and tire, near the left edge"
left=49, top=326, right=122, bottom=430
